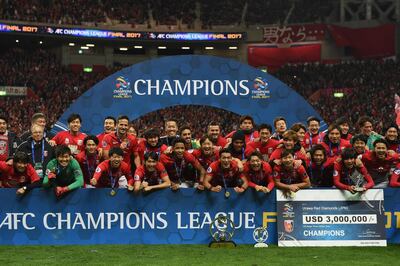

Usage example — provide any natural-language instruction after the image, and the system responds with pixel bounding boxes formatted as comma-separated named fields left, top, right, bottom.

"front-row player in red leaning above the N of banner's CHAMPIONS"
left=130, top=151, right=171, bottom=192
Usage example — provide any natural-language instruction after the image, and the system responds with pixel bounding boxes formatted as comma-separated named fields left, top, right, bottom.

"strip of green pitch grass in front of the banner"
left=0, top=245, right=400, bottom=266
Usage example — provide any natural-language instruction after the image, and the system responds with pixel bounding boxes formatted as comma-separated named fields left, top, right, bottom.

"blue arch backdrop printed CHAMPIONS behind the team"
left=56, top=55, right=320, bottom=134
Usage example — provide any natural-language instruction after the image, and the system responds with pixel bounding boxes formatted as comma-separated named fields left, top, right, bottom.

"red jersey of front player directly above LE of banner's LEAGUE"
left=160, top=151, right=201, bottom=183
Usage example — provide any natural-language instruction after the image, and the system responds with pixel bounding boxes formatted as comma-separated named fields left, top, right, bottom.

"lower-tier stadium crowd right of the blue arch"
left=275, top=60, right=400, bottom=132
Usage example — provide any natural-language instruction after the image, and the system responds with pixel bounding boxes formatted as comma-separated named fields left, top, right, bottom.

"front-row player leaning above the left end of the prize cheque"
left=273, top=150, right=311, bottom=197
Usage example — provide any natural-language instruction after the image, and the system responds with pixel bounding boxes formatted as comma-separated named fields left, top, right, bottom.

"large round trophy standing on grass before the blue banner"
left=208, top=214, right=236, bottom=248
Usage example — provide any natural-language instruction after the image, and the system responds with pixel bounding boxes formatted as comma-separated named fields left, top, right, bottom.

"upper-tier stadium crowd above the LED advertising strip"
left=0, top=0, right=339, bottom=28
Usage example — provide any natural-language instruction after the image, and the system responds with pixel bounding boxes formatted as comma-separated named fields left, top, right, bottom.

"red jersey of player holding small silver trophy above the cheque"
left=333, top=163, right=374, bottom=190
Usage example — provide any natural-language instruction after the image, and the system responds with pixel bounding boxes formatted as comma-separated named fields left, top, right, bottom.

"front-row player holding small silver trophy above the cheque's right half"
left=333, top=148, right=374, bottom=193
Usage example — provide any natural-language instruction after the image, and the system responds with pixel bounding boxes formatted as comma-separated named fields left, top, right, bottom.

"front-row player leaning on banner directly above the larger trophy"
left=204, top=148, right=248, bottom=193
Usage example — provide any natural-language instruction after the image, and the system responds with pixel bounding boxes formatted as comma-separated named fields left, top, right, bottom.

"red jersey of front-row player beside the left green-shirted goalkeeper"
left=93, top=160, right=132, bottom=188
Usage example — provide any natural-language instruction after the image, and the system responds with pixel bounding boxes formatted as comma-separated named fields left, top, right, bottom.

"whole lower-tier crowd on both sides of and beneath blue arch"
left=0, top=48, right=400, bottom=138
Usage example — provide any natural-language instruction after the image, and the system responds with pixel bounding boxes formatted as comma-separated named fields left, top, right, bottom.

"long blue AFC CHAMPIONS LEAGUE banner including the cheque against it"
left=0, top=188, right=400, bottom=246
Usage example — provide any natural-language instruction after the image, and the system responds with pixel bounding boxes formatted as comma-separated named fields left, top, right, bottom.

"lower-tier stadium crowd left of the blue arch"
left=0, top=48, right=121, bottom=134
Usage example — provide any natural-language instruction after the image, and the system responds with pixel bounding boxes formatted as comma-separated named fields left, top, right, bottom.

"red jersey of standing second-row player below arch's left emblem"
left=102, top=132, right=138, bottom=165
